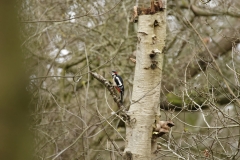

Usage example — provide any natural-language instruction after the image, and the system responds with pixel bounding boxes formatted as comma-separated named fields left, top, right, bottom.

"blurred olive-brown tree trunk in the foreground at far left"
left=0, top=0, right=32, bottom=160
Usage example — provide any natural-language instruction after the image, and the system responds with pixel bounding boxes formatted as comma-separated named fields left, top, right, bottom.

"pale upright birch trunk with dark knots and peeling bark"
left=125, top=1, right=166, bottom=160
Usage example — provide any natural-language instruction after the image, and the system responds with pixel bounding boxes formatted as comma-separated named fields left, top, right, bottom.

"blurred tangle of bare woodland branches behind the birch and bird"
left=2, top=0, right=240, bottom=160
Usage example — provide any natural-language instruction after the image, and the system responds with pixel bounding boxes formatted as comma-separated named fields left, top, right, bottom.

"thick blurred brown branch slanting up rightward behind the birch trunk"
left=162, top=25, right=240, bottom=92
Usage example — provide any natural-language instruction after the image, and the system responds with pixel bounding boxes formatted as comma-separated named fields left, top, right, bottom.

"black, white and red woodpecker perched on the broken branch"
left=112, top=71, right=124, bottom=103
